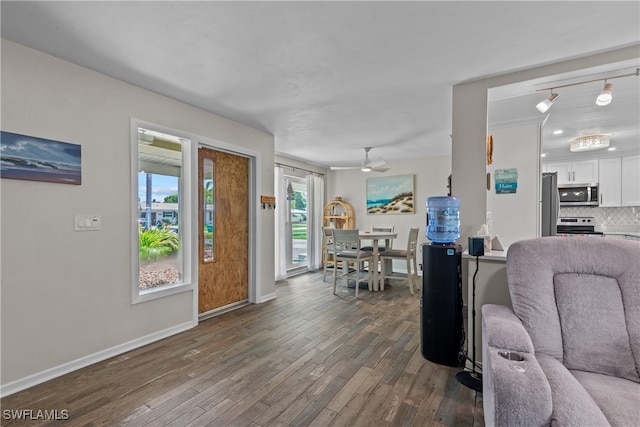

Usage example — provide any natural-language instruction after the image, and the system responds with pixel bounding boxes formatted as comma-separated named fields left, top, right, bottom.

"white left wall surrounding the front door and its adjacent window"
left=0, top=40, right=275, bottom=394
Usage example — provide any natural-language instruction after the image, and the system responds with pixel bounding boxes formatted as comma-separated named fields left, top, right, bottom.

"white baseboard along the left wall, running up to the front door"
left=0, top=321, right=197, bottom=397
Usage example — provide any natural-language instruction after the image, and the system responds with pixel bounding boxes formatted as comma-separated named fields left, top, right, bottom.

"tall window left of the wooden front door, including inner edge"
left=133, top=127, right=190, bottom=302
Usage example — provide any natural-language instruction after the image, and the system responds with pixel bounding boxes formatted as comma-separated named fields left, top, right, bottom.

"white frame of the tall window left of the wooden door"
left=130, top=119, right=191, bottom=304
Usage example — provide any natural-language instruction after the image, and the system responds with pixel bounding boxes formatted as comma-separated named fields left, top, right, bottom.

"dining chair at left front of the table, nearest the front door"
left=332, top=229, right=373, bottom=298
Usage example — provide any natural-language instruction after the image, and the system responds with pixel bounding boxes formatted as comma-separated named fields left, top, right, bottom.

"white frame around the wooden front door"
left=196, top=136, right=263, bottom=323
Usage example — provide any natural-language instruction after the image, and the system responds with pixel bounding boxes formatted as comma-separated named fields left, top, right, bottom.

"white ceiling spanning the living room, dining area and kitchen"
left=1, top=1, right=640, bottom=166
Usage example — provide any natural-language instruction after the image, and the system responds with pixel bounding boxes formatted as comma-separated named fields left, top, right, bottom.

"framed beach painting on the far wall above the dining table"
left=367, top=175, right=415, bottom=214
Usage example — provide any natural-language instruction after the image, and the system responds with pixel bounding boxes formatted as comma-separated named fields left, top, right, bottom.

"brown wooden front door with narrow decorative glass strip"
left=198, top=147, right=249, bottom=314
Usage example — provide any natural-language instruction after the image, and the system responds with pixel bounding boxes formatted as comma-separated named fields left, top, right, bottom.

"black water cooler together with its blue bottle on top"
left=420, top=196, right=463, bottom=366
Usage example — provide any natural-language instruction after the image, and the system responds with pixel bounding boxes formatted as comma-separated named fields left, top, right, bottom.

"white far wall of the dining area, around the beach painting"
left=326, top=156, right=451, bottom=260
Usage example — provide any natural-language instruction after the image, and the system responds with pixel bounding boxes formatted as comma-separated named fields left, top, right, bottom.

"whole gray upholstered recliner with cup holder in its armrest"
left=482, top=237, right=640, bottom=426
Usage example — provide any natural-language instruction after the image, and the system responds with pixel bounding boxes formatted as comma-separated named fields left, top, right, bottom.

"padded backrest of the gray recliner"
left=507, top=237, right=640, bottom=382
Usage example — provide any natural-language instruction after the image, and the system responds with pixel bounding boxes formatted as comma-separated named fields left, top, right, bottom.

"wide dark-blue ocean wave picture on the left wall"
left=0, top=131, right=82, bottom=185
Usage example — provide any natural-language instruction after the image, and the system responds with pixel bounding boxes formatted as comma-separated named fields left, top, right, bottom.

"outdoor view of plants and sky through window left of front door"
left=138, top=128, right=183, bottom=291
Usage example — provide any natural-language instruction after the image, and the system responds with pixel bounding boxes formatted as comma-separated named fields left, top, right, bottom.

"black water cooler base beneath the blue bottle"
left=420, top=244, right=462, bottom=366
